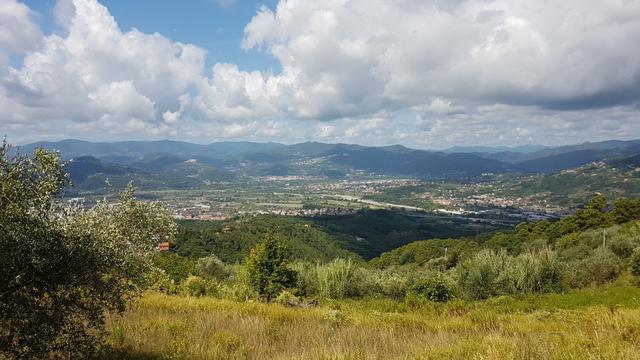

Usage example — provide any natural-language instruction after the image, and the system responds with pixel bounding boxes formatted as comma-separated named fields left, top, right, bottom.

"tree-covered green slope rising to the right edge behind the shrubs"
left=370, top=196, right=640, bottom=268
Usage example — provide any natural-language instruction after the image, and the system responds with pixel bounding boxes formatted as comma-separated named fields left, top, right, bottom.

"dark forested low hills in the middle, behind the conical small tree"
left=174, top=210, right=492, bottom=263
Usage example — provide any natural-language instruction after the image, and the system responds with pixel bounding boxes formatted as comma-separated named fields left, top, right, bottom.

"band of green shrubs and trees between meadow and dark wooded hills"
left=151, top=196, right=640, bottom=304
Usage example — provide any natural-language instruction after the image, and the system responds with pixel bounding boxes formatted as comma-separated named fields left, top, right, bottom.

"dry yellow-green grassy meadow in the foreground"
left=108, top=285, right=640, bottom=359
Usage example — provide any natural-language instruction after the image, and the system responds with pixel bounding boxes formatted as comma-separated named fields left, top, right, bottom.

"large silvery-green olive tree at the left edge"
left=0, top=143, right=175, bottom=358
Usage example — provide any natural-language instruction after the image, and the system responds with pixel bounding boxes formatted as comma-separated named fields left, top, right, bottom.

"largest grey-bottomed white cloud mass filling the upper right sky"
left=238, top=0, right=640, bottom=117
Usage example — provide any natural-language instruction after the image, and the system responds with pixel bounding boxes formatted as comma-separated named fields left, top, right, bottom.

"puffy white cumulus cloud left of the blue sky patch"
left=0, top=0, right=205, bottom=130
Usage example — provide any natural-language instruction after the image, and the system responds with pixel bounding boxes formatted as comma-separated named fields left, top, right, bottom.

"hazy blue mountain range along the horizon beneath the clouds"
left=12, top=136, right=640, bottom=187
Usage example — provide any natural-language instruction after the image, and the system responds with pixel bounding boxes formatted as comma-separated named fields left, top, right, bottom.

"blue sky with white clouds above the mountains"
left=0, top=0, right=640, bottom=149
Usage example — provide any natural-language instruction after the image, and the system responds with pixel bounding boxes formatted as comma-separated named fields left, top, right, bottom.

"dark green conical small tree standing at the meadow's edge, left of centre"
left=245, top=233, right=296, bottom=301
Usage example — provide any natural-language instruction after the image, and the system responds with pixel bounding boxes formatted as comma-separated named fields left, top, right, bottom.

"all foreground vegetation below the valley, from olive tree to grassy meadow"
left=0, top=145, right=640, bottom=359
